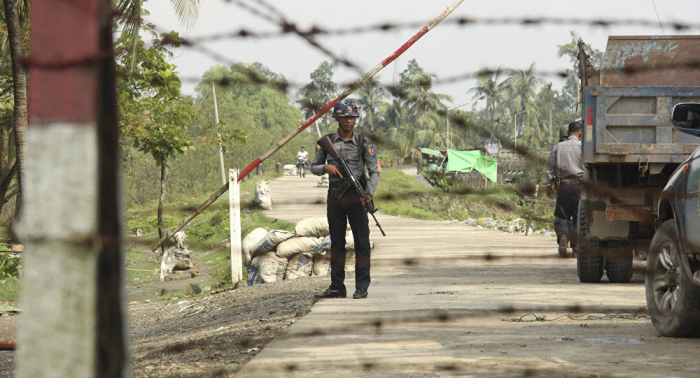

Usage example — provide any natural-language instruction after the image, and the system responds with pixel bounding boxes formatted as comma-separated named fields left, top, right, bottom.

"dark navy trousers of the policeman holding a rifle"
left=327, top=183, right=371, bottom=291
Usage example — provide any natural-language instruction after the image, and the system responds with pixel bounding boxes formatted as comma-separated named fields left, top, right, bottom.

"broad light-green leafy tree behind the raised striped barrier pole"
left=141, top=63, right=310, bottom=203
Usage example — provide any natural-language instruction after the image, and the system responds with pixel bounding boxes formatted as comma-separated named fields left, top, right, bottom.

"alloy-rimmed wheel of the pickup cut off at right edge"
left=645, top=219, right=700, bottom=337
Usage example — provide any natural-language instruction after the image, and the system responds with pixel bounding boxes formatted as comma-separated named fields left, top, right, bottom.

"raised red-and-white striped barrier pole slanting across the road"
left=151, top=0, right=464, bottom=253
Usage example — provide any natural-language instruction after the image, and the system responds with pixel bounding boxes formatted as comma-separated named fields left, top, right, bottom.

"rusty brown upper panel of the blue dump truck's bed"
left=600, top=35, right=700, bottom=87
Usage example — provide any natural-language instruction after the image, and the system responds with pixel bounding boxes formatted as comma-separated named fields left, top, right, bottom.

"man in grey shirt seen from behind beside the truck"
left=546, top=122, right=583, bottom=256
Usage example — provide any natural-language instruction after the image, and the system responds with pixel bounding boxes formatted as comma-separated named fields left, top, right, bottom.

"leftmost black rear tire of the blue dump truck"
left=576, top=199, right=603, bottom=283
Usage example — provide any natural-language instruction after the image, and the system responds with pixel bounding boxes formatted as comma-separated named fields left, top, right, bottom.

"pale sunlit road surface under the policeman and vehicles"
left=236, top=172, right=700, bottom=377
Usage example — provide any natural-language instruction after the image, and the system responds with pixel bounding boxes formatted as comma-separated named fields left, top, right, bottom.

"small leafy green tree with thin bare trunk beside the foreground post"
left=116, top=28, right=194, bottom=251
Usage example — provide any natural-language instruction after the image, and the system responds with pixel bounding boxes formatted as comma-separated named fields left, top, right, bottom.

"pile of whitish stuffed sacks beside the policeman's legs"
left=242, top=217, right=374, bottom=285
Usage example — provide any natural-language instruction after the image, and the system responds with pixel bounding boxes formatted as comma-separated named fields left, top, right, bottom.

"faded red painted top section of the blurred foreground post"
left=28, top=0, right=101, bottom=125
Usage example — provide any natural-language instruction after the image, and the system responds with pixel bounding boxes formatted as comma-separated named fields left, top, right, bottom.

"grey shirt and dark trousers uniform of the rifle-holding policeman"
left=311, top=132, right=379, bottom=296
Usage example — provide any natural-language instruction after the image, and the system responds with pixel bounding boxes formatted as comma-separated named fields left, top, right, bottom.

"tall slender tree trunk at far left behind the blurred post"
left=4, top=0, right=27, bottom=224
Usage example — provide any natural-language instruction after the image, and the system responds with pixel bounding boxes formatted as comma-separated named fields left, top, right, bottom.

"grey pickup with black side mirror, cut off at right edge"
left=646, top=102, right=700, bottom=337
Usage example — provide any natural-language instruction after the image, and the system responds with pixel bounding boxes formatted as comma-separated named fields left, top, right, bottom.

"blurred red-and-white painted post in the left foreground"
left=16, top=0, right=130, bottom=378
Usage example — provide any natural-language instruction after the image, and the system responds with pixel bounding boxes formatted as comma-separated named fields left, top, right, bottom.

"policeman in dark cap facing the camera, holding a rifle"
left=311, top=100, right=379, bottom=299
